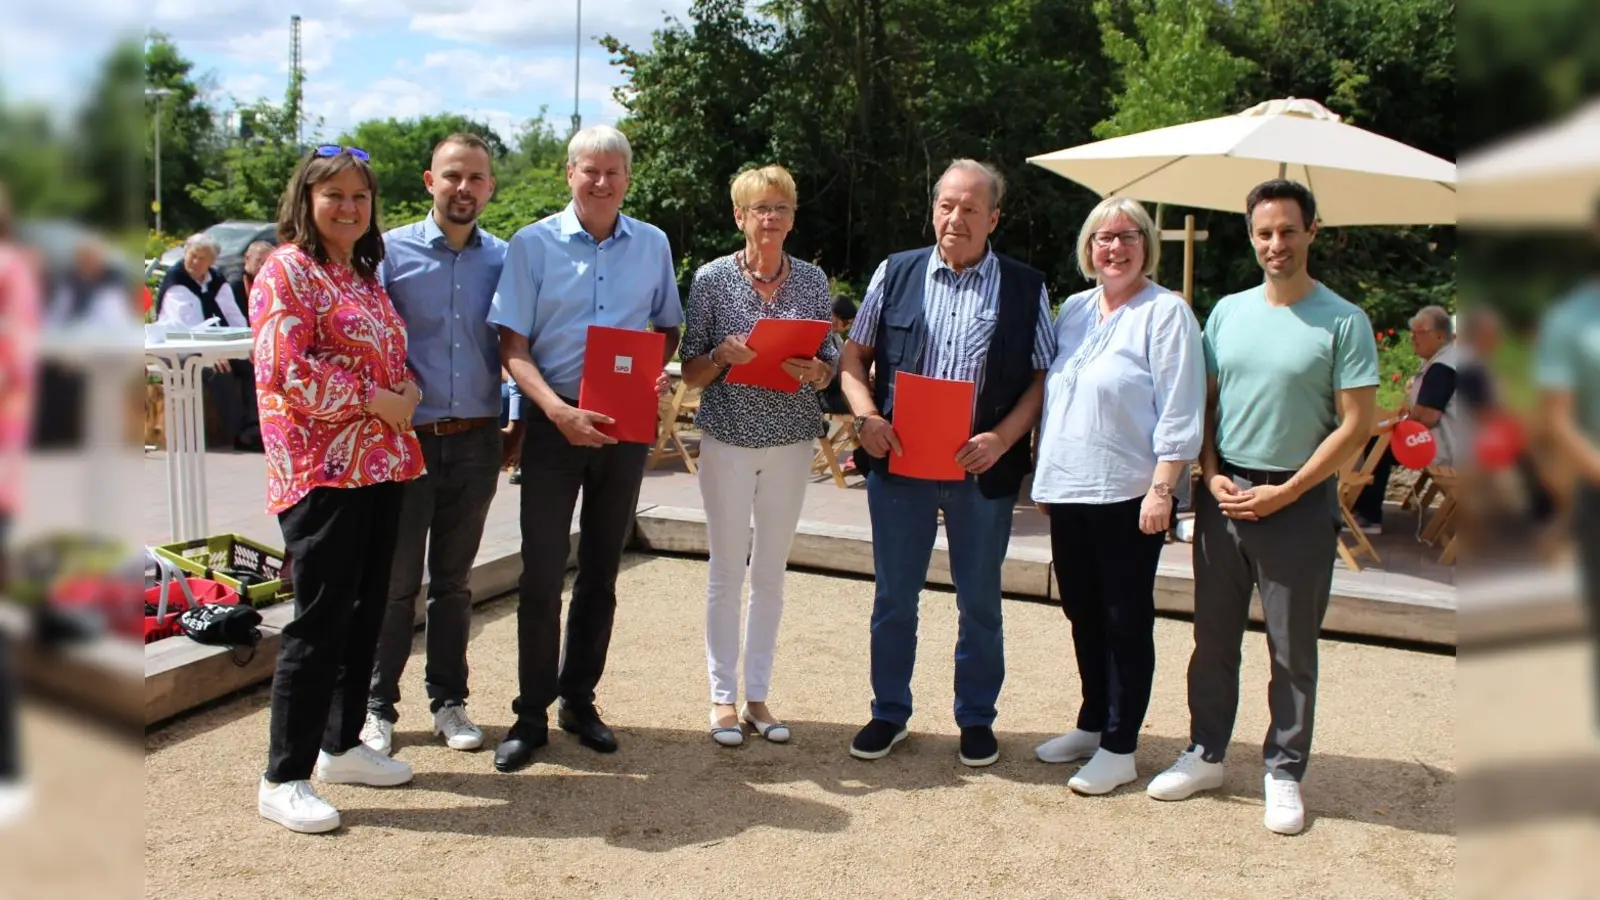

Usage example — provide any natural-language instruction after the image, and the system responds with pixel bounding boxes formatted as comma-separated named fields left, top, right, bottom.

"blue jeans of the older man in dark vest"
left=867, top=471, right=1016, bottom=727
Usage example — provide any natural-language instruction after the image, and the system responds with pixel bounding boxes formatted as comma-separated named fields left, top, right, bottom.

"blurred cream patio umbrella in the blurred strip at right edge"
left=1461, top=101, right=1600, bottom=227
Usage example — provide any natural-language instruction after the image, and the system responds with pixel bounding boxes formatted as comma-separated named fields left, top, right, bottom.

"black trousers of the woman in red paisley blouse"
left=266, top=484, right=403, bottom=783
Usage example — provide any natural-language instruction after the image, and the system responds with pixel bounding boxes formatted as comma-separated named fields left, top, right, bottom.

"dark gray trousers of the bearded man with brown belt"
left=366, top=426, right=501, bottom=722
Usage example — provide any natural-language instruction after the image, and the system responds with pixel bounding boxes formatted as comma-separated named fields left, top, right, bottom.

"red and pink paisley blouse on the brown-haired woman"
left=250, top=245, right=424, bottom=514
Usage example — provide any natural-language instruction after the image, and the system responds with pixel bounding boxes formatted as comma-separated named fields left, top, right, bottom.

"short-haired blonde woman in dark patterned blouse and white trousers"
left=682, top=165, right=838, bottom=746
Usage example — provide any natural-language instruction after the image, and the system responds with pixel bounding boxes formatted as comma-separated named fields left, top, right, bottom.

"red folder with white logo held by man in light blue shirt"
left=578, top=325, right=667, bottom=444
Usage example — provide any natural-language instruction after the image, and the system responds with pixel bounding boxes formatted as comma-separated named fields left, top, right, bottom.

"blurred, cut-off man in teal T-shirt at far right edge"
left=1538, top=269, right=1600, bottom=722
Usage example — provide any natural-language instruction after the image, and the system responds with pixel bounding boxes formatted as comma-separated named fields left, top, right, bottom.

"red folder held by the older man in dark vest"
left=890, top=372, right=976, bottom=480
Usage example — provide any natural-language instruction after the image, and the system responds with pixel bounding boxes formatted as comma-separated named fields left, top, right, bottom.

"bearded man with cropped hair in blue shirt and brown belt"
left=362, top=135, right=506, bottom=753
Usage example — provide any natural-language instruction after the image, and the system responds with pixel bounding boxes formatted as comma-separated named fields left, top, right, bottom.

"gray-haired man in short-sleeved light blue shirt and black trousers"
left=488, top=125, right=683, bottom=772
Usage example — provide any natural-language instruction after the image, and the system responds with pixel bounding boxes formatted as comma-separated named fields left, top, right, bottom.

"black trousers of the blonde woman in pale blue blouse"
left=1050, top=496, right=1166, bottom=753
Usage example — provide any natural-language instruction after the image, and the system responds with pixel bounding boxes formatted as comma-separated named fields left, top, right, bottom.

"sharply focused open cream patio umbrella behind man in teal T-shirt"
left=1027, top=98, right=1456, bottom=296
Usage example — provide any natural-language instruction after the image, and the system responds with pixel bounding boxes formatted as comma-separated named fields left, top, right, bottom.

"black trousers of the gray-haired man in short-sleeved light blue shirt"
left=512, top=404, right=650, bottom=721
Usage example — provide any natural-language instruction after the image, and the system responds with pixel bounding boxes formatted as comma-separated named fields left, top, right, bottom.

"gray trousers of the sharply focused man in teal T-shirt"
left=1189, top=472, right=1338, bottom=781
